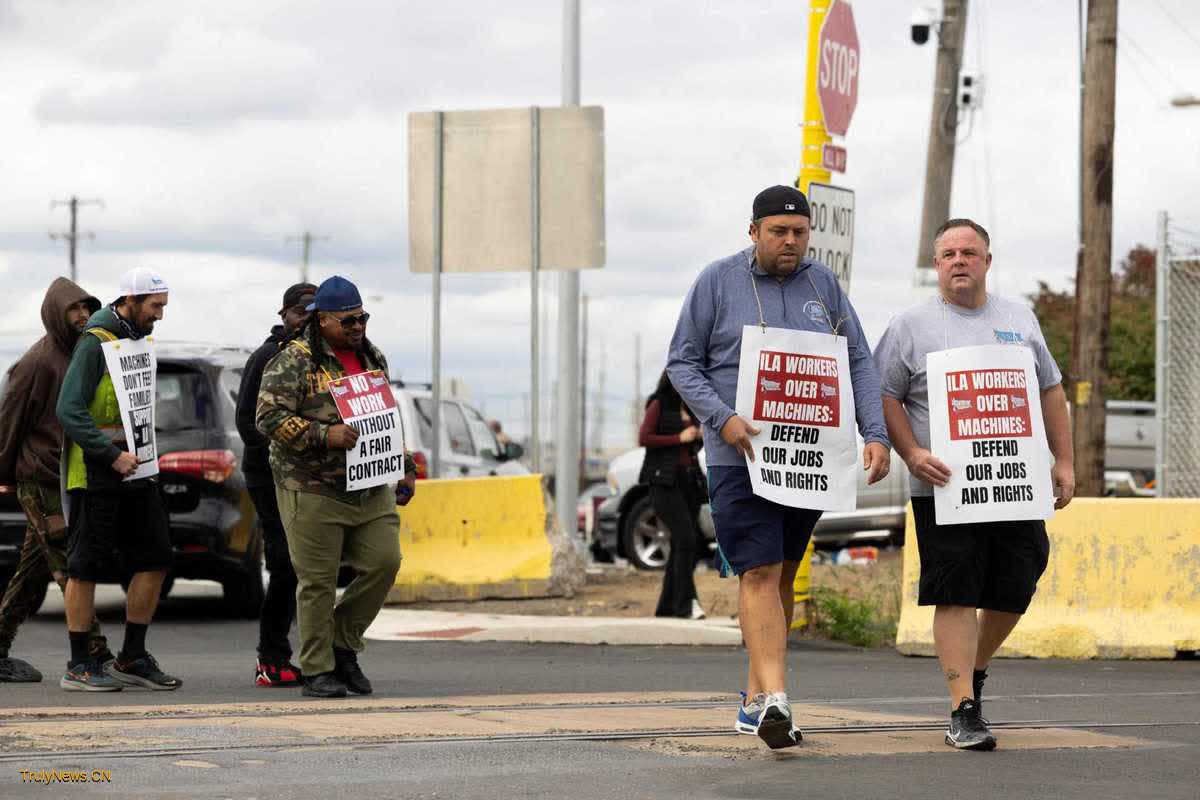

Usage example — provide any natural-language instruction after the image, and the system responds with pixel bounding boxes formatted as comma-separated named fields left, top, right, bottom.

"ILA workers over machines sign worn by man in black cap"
left=737, top=325, right=858, bottom=511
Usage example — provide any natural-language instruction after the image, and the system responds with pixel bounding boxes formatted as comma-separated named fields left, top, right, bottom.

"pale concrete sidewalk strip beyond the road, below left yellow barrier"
left=366, top=607, right=742, bottom=646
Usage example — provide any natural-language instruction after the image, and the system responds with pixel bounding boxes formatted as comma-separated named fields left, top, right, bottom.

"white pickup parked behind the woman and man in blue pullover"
left=592, top=440, right=908, bottom=570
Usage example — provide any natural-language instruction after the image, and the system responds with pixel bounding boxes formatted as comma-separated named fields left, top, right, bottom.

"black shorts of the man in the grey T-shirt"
left=912, top=498, right=1050, bottom=614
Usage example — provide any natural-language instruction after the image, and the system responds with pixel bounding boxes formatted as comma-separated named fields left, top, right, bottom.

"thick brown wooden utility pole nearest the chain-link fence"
left=1070, top=0, right=1117, bottom=497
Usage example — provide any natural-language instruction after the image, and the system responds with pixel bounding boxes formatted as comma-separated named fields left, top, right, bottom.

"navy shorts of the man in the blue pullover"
left=708, top=467, right=821, bottom=575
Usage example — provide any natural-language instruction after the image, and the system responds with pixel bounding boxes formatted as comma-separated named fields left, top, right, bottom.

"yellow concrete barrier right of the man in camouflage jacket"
left=388, top=475, right=583, bottom=602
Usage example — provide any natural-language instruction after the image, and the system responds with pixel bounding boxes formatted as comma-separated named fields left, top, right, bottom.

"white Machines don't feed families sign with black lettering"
left=100, top=338, right=158, bottom=481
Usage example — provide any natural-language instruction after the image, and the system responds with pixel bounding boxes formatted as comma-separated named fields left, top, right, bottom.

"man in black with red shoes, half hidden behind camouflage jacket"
left=236, top=283, right=317, bottom=686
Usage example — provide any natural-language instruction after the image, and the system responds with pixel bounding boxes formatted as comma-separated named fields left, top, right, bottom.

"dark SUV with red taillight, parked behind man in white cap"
left=0, top=342, right=263, bottom=616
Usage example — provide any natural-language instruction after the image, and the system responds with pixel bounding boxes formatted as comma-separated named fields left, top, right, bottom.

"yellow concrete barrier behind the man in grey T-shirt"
left=896, top=498, right=1200, bottom=658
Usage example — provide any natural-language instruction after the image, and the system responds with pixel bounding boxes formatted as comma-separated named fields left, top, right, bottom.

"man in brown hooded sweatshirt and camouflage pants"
left=0, top=278, right=106, bottom=684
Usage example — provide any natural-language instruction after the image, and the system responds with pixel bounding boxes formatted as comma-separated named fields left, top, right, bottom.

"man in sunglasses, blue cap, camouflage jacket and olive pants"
left=256, top=276, right=416, bottom=697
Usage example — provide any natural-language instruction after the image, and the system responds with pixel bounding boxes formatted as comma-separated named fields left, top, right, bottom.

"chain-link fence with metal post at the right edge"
left=1157, top=249, right=1200, bottom=498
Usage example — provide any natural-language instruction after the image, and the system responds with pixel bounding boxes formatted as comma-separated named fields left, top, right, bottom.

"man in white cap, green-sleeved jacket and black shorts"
left=56, top=267, right=181, bottom=692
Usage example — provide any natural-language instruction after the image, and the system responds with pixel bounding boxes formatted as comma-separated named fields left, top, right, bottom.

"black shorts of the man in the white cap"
left=67, top=481, right=172, bottom=581
